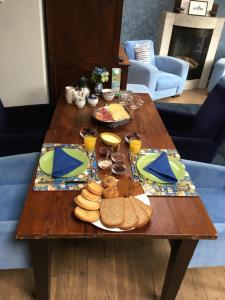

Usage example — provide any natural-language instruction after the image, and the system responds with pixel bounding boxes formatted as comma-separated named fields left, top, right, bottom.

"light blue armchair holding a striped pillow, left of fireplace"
left=124, top=40, right=189, bottom=100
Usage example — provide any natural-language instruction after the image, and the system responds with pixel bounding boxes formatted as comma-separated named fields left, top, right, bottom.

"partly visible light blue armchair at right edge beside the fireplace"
left=208, top=58, right=225, bottom=92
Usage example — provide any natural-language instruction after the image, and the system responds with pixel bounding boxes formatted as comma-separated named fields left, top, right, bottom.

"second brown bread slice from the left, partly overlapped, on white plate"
left=119, top=198, right=138, bottom=230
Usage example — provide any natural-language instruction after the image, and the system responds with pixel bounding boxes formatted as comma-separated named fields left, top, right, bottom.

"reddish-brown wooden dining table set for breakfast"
left=16, top=94, right=217, bottom=300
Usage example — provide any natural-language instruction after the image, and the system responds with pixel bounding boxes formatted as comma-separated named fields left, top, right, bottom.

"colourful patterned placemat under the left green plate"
left=33, top=143, right=98, bottom=191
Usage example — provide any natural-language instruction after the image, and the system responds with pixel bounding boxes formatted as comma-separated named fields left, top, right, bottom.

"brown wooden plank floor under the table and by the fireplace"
left=0, top=90, right=225, bottom=300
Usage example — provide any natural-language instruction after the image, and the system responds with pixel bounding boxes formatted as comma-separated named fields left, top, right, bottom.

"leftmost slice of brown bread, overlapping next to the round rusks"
left=100, top=198, right=124, bottom=228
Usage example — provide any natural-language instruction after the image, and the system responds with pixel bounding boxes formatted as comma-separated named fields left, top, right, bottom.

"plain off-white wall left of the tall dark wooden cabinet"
left=0, top=0, right=48, bottom=106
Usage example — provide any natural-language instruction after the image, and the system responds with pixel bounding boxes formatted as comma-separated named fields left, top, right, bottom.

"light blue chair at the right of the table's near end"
left=183, top=160, right=225, bottom=268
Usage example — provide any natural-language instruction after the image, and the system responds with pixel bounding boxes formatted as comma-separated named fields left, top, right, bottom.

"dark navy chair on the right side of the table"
left=158, top=84, right=225, bottom=163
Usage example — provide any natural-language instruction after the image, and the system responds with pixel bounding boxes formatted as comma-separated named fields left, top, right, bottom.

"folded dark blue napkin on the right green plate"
left=144, top=152, right=177, bottom=183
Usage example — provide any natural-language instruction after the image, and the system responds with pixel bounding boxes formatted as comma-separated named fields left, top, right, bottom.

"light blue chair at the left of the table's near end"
left=0, top=152, right=39, bottom=269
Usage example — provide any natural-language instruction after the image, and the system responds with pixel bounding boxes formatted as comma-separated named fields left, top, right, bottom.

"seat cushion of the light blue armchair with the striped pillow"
left=156, top=71, right=181, bottom=91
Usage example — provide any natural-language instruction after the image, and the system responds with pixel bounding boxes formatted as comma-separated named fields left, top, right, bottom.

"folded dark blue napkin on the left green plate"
left=52, top=147, right=83, bottom=177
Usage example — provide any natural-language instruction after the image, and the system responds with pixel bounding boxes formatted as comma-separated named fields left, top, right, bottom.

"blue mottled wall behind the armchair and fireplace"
left=121, top=0, right=225, bottom=60
